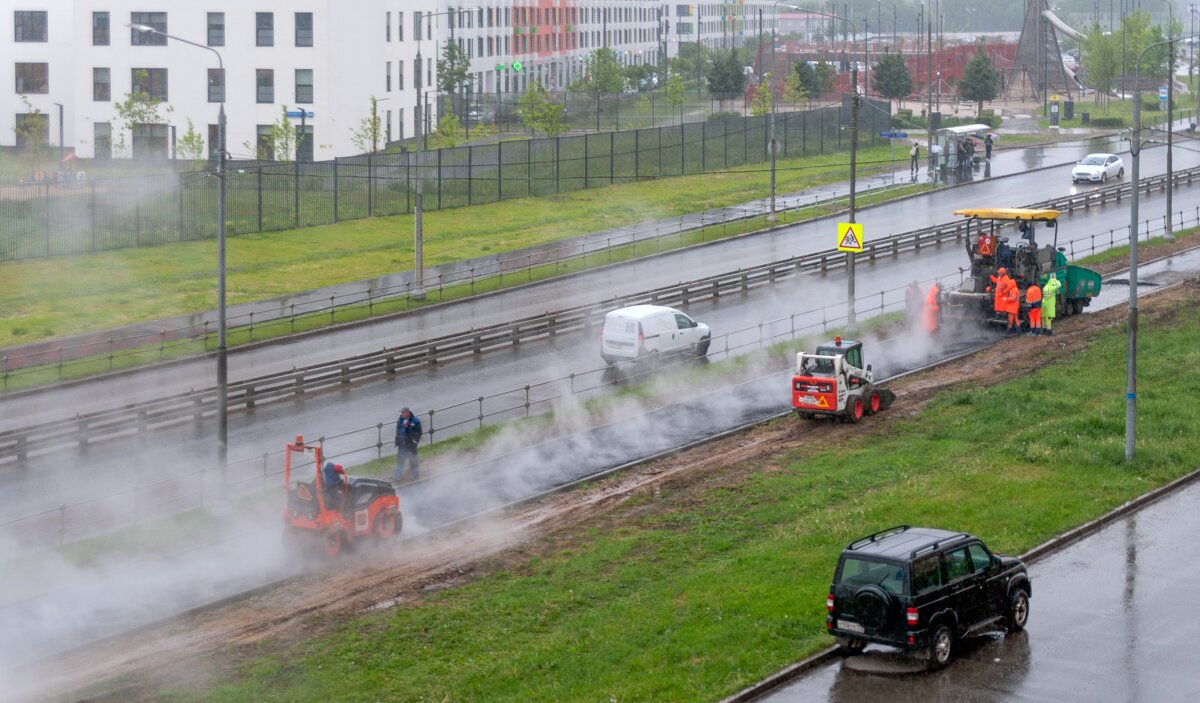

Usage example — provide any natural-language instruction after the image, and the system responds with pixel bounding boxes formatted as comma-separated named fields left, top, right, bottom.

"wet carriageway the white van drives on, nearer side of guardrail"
left=7, top=158, right=1200, bottom=530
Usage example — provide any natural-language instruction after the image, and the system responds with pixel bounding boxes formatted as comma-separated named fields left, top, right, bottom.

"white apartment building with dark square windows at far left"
left=0, top=0, right=436, bottom=160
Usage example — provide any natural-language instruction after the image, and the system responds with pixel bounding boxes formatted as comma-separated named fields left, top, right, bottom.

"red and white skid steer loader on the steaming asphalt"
left=792, top=337, right=895, bottom=422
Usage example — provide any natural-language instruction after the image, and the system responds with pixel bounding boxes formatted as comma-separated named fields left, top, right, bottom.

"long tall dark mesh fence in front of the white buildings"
left=0, top=101, right=890, bottom=262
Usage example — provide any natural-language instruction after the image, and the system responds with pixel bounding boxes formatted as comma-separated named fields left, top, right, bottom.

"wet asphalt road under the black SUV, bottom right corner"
left=758, top=483, right=1200, bottom=703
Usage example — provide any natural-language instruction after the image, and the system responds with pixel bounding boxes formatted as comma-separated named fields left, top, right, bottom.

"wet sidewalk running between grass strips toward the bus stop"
left=0, top=121, right=1118, bottom=371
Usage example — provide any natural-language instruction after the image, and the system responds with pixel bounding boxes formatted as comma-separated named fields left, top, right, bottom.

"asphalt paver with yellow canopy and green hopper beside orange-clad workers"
left=942, top=208, right=1100, bottom=326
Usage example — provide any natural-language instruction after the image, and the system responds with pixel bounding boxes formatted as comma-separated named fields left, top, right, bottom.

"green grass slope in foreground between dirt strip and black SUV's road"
left=129, top=284, right=1200, bottom=703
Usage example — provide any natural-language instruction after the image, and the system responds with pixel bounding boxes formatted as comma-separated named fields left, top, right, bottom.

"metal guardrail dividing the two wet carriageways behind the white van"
left=0, top=161, right=1200, bottom=462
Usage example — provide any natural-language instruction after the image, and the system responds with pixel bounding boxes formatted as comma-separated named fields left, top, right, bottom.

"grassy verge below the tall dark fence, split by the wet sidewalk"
left=0, top=148, right=931, bottom=390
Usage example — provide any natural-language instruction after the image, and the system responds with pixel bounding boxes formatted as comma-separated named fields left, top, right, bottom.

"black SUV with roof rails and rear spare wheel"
left=826, top=525, right=1031, bottom=669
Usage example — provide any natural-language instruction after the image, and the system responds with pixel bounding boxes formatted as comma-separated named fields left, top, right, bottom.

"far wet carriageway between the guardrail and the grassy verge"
left=0, top=136, right=1180, bottom=429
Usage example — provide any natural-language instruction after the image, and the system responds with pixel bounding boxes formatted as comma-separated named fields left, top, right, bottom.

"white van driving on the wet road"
left=600, top=305, right=712, bottom=365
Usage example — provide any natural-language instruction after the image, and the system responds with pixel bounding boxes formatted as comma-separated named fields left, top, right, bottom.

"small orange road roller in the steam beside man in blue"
left=283, top=435, right=402, bottom=557
